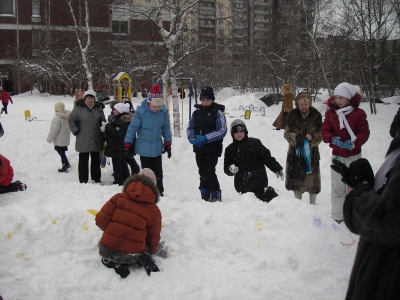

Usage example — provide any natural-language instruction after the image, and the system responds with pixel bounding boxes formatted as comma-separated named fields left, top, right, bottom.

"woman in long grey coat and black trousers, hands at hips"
left=68, top=90, right=106, bottom=183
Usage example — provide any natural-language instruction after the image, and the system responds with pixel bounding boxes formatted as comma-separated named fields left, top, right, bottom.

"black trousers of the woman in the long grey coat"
left=78, top=152, right=101, bottom=183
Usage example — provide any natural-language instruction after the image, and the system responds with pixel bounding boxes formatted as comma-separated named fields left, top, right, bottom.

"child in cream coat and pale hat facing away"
left=47, top=102, right=71, bottom=173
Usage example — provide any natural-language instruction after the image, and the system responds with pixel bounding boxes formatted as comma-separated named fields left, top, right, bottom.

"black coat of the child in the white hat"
left=105, top=113, right=133, bottom=158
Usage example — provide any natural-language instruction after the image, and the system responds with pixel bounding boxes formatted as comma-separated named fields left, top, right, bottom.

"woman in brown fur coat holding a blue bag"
left=284, top=93, right=322, bottom=204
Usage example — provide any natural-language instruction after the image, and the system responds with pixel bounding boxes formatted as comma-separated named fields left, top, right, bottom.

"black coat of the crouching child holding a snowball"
left=224, top=135, right=282, bottom=193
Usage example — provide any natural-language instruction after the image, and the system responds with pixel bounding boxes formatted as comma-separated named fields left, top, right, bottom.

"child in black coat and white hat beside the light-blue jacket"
left=104, top=103, right=133, bottom=185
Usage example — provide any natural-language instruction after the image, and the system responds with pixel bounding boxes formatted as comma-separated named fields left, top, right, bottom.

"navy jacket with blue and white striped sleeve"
left=186, top=102, right=227, bottom=156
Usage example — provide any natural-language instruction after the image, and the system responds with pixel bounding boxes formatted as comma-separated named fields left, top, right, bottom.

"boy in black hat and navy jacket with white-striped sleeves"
left=186, top=86, right=227, bottom=202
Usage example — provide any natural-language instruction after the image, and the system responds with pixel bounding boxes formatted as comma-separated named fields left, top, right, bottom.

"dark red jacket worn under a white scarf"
left=321, top=94, right=369, bottom=158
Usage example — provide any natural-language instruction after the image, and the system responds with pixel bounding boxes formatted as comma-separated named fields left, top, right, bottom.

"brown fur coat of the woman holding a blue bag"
left=284, top=106, right=322, bottom=194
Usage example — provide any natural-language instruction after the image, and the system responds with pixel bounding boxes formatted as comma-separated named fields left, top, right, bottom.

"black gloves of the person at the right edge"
left=331, top=158, right=375, bottom=188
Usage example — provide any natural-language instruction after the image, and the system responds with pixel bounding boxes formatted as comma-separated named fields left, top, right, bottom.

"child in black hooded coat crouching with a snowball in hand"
left=224, top=119, right=283, bottom=202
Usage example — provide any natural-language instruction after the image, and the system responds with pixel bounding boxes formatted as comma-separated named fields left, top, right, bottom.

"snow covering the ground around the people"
left=0, top=88, right=400, bottom=300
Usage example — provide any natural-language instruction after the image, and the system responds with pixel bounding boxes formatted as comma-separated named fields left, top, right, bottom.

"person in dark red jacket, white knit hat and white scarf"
left=321, top=82, right=369, bottom=223
